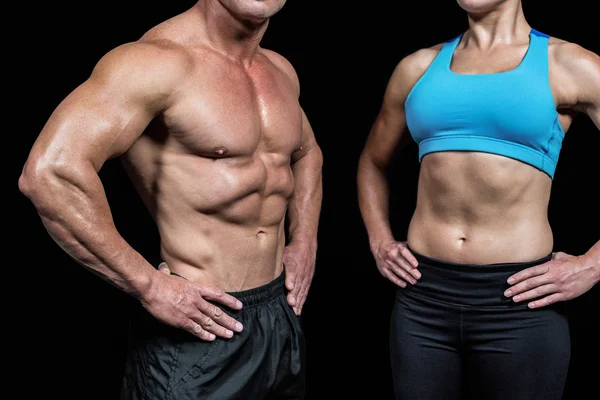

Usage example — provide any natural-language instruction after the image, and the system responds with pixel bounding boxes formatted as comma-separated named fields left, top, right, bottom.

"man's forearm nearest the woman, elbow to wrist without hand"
left=288, top=146, right=323, bottom=248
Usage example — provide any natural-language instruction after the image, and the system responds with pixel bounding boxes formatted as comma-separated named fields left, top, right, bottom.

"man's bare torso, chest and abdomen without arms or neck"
left=123, top=14, right=302, bottom=291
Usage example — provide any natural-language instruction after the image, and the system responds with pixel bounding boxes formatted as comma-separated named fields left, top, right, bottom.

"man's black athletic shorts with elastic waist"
left=121, top=274, right=305, bottom=400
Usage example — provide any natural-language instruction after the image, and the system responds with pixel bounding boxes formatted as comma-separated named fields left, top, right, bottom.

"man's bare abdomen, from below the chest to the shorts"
left=125, top=144, right=294, bottom=292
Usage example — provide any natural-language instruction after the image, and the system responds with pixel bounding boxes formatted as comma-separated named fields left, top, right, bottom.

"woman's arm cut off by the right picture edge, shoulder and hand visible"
left=505, top=43, right=600, bottom=308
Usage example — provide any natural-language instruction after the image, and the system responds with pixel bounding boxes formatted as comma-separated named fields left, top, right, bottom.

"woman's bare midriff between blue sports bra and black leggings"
left=408, top=152, right=553, bottom=265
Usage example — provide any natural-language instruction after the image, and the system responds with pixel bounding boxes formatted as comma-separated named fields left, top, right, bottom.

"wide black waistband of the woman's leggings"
left=398, top=249, right=552, bottom=308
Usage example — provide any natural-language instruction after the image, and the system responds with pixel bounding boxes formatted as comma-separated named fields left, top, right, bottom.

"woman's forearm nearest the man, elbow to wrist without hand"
left=357, top=155, right=394, bottom=248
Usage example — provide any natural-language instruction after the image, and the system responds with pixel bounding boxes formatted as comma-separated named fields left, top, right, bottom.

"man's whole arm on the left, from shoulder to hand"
left=19, top=43, right=244, bottom=339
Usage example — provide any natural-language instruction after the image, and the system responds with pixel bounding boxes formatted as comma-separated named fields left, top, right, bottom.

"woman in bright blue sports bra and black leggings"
left=358, top=0, right=600, bottom=400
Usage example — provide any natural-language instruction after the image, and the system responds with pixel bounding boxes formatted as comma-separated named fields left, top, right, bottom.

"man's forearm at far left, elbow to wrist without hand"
left=19, top=165, right=156, bottom=298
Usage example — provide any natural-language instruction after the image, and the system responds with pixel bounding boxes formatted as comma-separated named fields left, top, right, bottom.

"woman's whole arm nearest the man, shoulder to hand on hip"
left=357, top=48, right=438, bottom=287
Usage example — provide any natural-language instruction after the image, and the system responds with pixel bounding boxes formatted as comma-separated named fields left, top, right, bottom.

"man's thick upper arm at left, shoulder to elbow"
left=30, top=44, right=187, bottom=170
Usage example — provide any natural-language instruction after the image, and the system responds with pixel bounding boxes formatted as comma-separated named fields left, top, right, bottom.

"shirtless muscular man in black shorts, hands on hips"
left=19, top=0, right=322, bottom=399
